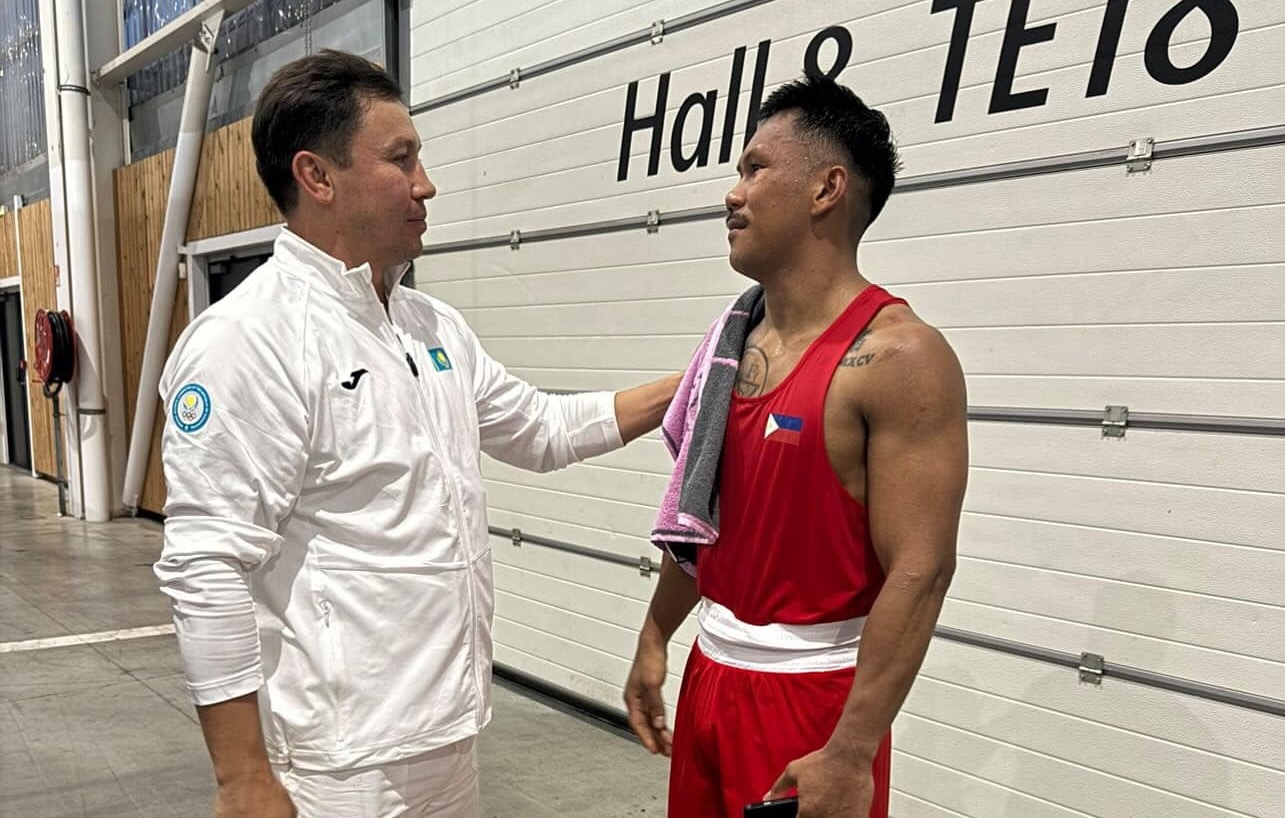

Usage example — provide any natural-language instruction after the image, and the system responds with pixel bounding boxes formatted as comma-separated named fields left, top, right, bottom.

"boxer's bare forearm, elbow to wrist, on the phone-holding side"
left=830, top=557, right=950, bottom=765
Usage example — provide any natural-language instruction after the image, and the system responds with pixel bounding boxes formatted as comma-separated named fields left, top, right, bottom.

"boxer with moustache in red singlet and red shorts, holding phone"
left=625, top=78, right=968, bottom=818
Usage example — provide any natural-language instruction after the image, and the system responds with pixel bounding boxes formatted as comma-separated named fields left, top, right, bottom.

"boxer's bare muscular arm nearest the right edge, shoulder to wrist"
left=830, top=325, right=968, bottom=768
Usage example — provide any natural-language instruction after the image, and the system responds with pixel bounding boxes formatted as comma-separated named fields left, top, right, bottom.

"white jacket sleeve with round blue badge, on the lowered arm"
left=154, top=309, right=308, bottom=705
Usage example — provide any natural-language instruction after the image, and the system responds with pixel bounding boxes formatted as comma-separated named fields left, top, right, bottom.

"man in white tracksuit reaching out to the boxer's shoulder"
left=155, top=51, right=677, bottom=818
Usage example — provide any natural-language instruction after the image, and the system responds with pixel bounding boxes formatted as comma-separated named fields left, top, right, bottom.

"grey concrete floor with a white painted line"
left=0, top=466, right=667, bottom=818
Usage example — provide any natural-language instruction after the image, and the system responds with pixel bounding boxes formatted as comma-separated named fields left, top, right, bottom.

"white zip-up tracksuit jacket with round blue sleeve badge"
left=155, top=231, right=621, bottom=770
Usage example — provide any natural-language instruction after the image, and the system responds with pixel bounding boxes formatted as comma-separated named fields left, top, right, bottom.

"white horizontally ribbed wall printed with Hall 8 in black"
left=411, top=0, right=1285, bottom=818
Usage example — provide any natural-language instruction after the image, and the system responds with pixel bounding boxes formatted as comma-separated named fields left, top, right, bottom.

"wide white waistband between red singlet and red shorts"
left=696, top=600, right=866, bottom=673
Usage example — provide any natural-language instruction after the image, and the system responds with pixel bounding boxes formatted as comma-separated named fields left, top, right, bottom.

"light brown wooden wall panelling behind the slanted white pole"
left=114, top=118, right=283, bottom=514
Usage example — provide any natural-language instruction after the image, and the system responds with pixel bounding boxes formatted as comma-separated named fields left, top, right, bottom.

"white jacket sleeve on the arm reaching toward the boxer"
left=465, top=321, right=625, bottom=471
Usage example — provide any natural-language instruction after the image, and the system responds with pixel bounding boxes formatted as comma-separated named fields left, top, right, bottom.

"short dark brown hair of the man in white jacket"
left=251, top=49, right=402, bottom=214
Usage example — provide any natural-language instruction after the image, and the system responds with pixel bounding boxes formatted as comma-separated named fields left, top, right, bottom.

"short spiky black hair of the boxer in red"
left=759, top=74, right=901, bottom=222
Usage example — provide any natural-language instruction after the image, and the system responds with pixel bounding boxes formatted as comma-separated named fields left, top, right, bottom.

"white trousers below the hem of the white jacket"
left=274, top=738, right=481, bottom=818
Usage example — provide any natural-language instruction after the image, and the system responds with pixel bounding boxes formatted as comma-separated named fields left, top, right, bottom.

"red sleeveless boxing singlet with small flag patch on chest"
left=696, top=285, right=906, bottom=624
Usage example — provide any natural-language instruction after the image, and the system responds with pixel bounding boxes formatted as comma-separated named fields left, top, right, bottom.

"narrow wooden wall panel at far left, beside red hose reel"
left=17, top=199, right=67, bottom=476
